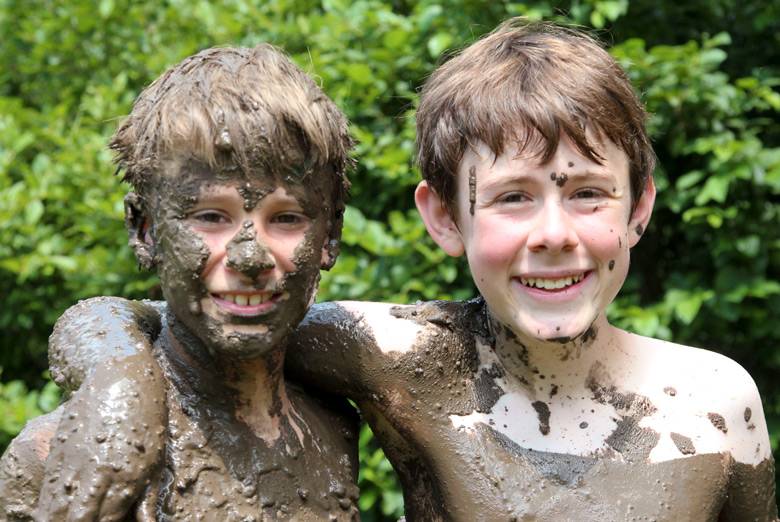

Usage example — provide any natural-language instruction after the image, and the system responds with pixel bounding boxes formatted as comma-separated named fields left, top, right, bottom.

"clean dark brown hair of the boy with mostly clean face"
left=415, top=18, right=655, bottom=217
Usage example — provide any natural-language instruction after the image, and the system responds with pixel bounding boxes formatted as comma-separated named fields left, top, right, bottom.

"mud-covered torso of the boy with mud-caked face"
left=149, top=330, right=360, bottom=522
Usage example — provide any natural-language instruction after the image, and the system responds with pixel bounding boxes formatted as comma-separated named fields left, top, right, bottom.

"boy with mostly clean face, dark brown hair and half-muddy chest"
left=13, top=21, right=777, bottom=522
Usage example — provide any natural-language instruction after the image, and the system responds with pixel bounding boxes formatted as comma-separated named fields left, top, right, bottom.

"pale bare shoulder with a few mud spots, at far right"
left=626, top=334, right=771, bottom=465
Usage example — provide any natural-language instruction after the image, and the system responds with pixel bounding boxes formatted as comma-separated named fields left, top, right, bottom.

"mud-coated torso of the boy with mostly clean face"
left=350, top=299, right=774, bottom=522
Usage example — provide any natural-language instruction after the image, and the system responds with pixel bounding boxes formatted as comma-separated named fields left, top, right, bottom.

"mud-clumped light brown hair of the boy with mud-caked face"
left=108, top=44, right=353, bottom=215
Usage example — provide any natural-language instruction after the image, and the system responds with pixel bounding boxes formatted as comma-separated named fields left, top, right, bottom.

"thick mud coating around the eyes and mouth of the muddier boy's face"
left=145, top=159, right=329, bottom=358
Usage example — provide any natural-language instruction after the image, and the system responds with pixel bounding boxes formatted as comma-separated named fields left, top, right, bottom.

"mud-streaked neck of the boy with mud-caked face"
left=162, top=308, right=301, bottom=444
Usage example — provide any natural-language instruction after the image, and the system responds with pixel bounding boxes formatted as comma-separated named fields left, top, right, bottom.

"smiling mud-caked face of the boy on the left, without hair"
left=150, top=161, right=329, bottom=358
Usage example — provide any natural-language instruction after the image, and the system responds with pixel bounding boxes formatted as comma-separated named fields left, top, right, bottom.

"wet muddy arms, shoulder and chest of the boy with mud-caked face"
left=0, top=298, right=359, bottom=521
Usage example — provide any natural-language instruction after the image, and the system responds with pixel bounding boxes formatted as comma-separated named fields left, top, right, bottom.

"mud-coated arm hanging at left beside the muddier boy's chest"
left=36, top=298, right=167, bottom=521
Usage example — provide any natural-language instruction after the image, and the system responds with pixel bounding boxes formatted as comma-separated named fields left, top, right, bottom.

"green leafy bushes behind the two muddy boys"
left=0, top=0, right=780, bottom=521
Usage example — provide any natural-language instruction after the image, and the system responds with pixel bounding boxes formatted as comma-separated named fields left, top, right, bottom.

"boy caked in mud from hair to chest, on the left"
left=0, top=45, right=359, bottom=521
